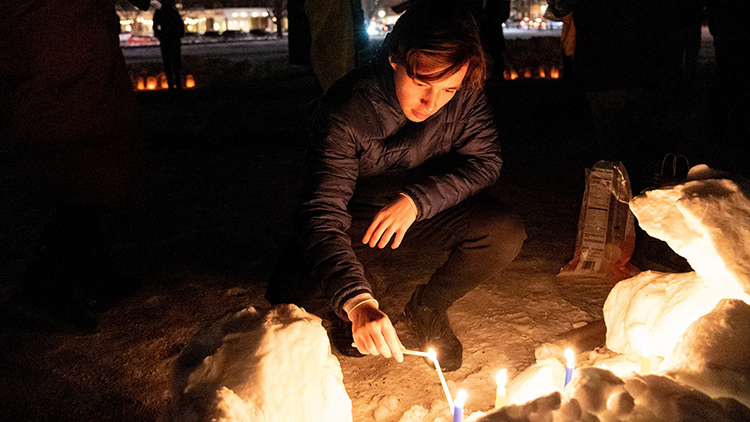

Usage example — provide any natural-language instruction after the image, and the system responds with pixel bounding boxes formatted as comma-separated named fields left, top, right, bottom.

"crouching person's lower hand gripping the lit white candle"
left=349, top=303, right=404, bottom=362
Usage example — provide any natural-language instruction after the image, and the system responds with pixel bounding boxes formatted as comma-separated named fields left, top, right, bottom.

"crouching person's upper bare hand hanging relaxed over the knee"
left=362, top=195, right=417, bottom=249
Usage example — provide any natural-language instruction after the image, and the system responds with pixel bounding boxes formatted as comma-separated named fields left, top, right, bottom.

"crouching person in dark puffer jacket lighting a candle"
left=266, top=2, right=526, bottom=371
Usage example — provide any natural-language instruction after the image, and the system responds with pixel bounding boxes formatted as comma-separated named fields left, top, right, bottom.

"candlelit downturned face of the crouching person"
left=390, top=56, right=469, bottom=122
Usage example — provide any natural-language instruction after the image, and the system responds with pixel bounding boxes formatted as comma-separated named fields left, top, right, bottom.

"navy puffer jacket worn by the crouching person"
left=296, top=61, right=502, bottom=319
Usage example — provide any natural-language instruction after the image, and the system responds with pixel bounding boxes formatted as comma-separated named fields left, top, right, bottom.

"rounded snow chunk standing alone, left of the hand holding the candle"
left=168, top=305, right=352, bottom=422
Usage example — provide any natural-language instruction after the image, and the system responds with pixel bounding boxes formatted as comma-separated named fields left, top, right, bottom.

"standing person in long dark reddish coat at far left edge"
left=0, top=0, right=149, bottom=329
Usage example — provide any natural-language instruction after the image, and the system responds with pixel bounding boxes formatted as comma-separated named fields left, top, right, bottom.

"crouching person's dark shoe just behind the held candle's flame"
left=404, top=285, right=463, bottom=372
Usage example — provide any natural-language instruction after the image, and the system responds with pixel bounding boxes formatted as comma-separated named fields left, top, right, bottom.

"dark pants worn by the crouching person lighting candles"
left=266, top=194, right=526, bottom=315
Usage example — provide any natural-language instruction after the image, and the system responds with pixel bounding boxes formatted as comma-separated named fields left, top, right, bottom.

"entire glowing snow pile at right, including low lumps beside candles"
left=466, top=166, right=750, bottom=422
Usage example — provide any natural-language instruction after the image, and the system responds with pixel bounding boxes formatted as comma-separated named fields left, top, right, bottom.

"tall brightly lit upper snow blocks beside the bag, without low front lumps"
left=604, top=166, right=750, bottom=360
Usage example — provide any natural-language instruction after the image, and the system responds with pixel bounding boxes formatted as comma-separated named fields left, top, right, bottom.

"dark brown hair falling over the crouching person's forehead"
left=381, top=1, right=487, bottom=91
